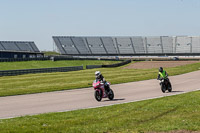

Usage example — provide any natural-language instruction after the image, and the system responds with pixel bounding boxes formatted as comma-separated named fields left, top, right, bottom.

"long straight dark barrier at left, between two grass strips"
left=0, top=66, right=83, bottom=76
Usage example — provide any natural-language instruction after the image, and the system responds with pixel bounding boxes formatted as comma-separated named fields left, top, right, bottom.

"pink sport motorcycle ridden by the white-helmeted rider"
left=93, top=80, right=114, bottom=102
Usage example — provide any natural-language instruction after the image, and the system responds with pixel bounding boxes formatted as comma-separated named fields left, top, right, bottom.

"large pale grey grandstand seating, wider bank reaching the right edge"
left=53, top=36, right=200, bottom=55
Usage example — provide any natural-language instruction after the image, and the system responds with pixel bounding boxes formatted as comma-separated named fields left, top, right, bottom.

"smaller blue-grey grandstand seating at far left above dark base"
left=0, top=41, right=40, bottom=52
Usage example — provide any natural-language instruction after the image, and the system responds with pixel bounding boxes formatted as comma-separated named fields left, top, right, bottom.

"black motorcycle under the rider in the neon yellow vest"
left=160, top=78, right=172, bottom=93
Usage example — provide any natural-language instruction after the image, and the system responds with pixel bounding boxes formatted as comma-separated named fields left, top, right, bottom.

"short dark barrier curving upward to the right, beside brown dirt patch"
left=86, top=60, right=131, bottom=69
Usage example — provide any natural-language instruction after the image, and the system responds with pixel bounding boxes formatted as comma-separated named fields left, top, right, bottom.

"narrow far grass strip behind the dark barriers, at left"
left=0, top=60, right=120, bottom=70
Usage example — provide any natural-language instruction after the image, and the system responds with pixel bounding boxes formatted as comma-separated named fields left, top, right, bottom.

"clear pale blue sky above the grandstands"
left=0, top=0, right=200, bottom=50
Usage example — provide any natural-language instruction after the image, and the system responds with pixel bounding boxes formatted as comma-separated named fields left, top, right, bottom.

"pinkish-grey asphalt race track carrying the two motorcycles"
left=0, top=71, right=200, bottom=119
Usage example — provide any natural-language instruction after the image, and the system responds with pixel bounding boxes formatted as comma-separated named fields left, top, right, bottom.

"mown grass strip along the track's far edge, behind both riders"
left=0, top=63, right=200, bottom=96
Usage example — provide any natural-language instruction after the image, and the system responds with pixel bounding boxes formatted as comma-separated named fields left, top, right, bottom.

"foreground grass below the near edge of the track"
left=0, top=91, right=200, bottom=133
